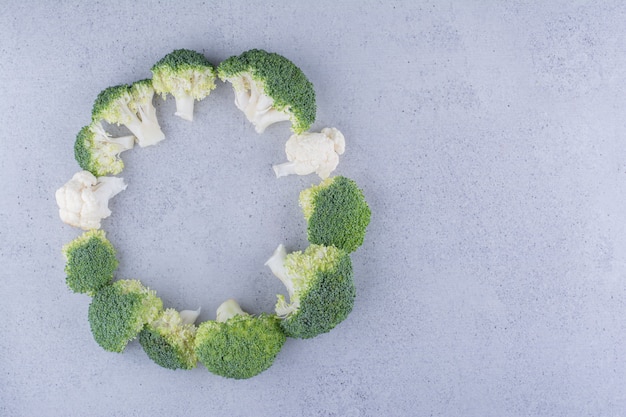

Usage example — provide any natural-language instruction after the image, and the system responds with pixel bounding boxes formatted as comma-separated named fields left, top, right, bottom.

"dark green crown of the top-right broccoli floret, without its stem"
left=217, top=49, right=317, bottom=133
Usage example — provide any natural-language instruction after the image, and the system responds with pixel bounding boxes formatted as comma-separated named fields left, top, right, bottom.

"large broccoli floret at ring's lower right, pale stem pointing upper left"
left=265, top=245, right=356, bottom=339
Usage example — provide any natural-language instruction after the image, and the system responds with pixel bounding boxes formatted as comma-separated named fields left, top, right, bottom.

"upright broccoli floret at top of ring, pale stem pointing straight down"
left=152, top=49, right=217, bottom=121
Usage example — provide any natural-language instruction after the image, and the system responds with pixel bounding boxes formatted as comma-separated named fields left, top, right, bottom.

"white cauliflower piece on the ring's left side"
left=55, top=171, right=126, bottom=230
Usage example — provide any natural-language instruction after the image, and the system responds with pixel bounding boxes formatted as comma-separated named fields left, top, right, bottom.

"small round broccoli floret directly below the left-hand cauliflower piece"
left=62, top=230, right=118, bottom=296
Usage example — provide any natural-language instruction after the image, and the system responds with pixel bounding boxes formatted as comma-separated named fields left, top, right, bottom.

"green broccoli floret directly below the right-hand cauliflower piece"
left=300, top=177, right=371, bottom=252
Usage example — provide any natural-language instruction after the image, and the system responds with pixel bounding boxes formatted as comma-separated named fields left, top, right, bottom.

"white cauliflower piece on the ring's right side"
left=272, top=127, right=346, bottom=179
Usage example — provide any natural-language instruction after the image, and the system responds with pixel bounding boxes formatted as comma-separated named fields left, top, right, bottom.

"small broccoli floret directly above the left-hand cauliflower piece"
left=74, top=122, right=135, bottom=177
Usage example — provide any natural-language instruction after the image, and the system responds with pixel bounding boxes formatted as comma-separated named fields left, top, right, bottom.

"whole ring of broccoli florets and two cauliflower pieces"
left=56, top=49, right=371, bottom=379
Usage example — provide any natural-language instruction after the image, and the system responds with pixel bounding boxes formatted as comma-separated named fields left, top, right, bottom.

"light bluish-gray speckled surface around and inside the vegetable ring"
left=0, top=0, right=626, bottom=417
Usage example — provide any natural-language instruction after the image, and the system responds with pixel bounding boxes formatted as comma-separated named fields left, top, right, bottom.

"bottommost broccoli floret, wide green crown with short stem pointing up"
left=195, top=299, right=286, bottom=379
